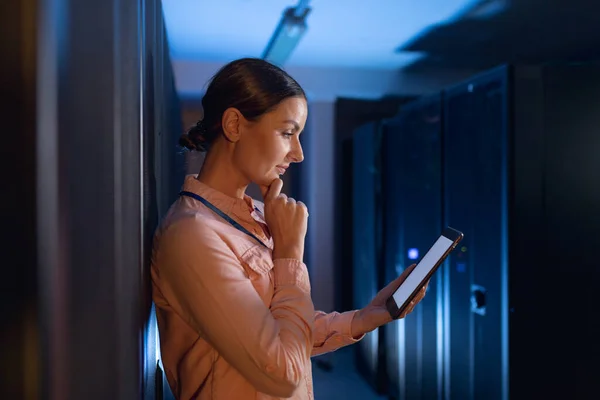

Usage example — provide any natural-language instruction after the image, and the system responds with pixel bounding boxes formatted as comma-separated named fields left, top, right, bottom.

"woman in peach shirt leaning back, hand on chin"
left=152, top=59, right=425, bottom=400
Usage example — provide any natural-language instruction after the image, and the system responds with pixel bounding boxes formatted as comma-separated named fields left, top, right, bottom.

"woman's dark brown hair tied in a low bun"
left=179, top=58, right=306, bottom=151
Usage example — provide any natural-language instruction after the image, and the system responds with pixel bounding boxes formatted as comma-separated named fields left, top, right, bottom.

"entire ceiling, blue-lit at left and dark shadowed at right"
left=162, top=0, right=600, bottom=99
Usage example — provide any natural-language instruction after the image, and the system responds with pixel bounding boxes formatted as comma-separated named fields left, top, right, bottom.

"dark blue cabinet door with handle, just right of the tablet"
left=444, top=68, right=507, bottom=400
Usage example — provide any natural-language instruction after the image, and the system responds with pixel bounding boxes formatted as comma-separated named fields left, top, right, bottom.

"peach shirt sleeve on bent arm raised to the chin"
left=156, top=220, right=314, bottom=397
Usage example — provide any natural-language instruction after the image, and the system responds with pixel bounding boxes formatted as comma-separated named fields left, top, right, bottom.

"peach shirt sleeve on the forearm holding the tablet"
left=312, top=311, right=365, bottom=356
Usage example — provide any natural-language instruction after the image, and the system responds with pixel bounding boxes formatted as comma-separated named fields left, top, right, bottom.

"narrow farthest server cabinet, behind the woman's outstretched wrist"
left=352, top=122, right=382, bottom=391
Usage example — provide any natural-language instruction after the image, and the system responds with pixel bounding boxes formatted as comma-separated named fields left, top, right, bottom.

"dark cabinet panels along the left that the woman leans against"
left=0, top=0, right=181, bottom=400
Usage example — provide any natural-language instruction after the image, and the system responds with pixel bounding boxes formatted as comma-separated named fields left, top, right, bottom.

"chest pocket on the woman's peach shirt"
left=241, top=245, right=274, bottom=307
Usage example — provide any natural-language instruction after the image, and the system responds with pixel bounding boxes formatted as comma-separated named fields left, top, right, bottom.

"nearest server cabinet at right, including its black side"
left=443, top=65, right=600, bottom=400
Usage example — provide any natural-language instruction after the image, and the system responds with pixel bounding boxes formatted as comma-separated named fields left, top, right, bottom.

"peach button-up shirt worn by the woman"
left=151, top=176, right=364, bottom=400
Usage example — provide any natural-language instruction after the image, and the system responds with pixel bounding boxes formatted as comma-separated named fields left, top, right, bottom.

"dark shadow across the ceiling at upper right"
left=397, top=0, right=600, bottom=72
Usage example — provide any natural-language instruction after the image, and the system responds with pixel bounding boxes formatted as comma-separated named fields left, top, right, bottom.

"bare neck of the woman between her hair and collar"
left=198, top=148, right=250, bottom=199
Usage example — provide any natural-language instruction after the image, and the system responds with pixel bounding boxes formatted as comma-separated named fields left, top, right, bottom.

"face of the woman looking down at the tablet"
left=233, top=97, right=308, bottom=186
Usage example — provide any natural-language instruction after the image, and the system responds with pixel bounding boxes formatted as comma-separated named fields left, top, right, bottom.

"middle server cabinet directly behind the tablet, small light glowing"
left=381, top=95, right=442, bottom=399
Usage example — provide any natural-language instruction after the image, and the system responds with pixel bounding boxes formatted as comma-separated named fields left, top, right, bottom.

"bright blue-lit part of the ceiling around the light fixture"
left=163, top=0, right=492, bottom=70
